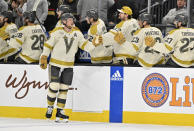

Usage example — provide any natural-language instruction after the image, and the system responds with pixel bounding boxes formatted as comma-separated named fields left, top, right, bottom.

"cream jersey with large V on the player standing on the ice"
left=42, top=27, right=95, bottom=68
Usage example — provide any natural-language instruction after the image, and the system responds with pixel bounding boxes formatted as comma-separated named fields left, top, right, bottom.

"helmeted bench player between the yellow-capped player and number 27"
left=131, top=13, right=164, bottom=68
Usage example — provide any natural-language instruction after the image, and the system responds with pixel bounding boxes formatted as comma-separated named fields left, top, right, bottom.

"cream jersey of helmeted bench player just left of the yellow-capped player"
left=88, top=19, right=113, bottom=63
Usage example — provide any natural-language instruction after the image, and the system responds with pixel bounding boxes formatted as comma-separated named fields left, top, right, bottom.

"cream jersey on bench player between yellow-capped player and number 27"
left=130, top=27, right=164, bottom=67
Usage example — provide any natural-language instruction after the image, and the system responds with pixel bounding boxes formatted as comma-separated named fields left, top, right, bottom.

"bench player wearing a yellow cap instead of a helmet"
left=102, top=6, right=139, bottom=64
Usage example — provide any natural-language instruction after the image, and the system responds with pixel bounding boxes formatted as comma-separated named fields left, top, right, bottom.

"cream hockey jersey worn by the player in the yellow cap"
left=103, top=18, right=140, bottom=60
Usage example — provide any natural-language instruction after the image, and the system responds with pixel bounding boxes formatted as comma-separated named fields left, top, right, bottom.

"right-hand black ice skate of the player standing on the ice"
left=55, top=109, right=69, bottom=123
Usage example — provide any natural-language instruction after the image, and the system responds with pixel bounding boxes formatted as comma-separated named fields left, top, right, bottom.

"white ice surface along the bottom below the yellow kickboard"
left=0, top=118, right=194, bottom=131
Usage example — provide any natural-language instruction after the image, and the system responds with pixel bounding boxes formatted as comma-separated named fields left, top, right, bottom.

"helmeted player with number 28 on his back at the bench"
left=9, top=12, right=46, bottom=64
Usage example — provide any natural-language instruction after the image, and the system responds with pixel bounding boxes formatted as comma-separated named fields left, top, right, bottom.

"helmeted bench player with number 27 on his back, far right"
left=157, top=14, right=194, bottom=67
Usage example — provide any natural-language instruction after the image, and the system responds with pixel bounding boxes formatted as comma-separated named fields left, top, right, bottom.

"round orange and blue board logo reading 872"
left=141, top=73, right=169, bottom=107
